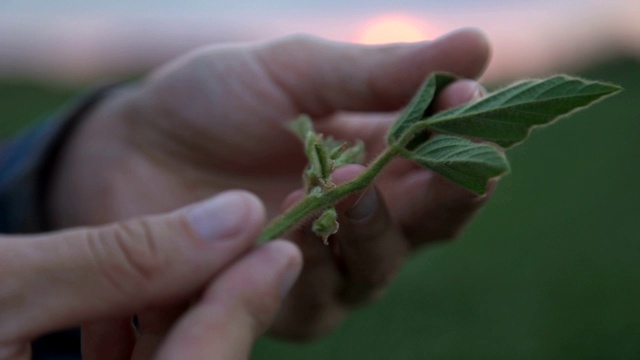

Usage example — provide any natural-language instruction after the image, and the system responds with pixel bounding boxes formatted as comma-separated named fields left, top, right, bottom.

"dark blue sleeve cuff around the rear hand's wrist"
left=0, top=85, right=113, bottom=234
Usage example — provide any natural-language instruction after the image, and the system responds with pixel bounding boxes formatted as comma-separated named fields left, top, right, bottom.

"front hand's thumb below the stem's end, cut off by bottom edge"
left=158, top=241, right=302, bottom=360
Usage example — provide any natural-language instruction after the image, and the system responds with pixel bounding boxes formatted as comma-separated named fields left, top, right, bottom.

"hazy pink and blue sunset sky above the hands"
left=0, top=0, right=640, bottom=82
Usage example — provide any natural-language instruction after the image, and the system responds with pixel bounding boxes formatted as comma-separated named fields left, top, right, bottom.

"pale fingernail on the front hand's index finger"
left=186, top=193, right=248, bottom=242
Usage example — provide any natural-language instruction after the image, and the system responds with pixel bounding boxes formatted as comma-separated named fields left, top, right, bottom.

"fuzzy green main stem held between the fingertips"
left=258, top=146, right=400, bottom=243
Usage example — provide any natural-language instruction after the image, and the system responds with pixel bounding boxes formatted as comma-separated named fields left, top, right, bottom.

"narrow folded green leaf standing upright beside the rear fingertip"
left=387, top=73, right=457, bottom=145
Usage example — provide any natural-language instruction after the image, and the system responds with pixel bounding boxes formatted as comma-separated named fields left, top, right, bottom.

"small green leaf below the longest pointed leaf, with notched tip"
left=402, top=135, right=509, bottom=194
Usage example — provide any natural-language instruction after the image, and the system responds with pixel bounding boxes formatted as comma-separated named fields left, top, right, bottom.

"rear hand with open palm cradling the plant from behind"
left=49, top=30, right=489, bottom=338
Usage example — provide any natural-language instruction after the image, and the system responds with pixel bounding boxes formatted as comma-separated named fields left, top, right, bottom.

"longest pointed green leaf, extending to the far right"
left=422, top=75, right=621, bottom=148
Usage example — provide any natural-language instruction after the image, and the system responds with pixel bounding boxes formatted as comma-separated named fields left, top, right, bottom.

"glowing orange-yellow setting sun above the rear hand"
left=356, top=15, right=433, bottom=44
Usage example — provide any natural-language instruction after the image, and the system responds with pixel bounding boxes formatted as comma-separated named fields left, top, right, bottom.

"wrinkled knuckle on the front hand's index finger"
left=88, top=220, right=168, bottom=296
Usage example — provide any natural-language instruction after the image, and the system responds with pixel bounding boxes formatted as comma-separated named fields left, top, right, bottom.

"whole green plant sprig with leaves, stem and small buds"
left=260, top=73, right=621, bottom=244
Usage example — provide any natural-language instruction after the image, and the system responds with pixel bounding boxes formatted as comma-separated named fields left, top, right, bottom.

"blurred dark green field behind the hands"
left=0, top=59, right=640, bottom=360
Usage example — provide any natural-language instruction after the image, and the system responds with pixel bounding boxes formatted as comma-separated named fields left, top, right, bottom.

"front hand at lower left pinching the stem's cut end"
left=0, top=192, right=302, bottom=360
